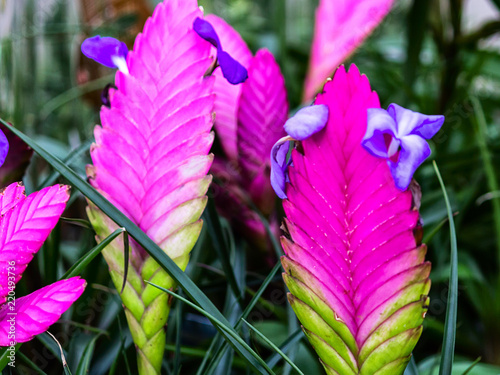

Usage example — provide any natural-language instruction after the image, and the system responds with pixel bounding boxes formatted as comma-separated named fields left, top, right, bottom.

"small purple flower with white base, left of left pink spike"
left=81, top=35, right=128, bottom=74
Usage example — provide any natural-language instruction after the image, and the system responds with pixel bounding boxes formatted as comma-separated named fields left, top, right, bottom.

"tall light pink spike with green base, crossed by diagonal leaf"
left=82, top=0, right=248, bottom=374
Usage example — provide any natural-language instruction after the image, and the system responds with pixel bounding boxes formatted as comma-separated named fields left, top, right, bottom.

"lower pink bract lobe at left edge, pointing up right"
left=0, top=276, right=86, bottom=346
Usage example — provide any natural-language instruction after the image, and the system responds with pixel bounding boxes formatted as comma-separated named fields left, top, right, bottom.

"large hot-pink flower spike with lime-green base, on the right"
left=281, top=65, right=430, bottom=375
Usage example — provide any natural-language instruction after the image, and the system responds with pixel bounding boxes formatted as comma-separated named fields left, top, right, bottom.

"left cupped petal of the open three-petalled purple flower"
left=361, top=108, right=399, bottom=158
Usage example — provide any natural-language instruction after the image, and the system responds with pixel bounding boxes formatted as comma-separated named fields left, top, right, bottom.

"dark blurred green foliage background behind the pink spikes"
left=0, top=0, right=500, bottom=374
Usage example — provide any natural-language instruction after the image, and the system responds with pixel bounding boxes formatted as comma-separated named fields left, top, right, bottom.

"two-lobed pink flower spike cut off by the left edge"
left=0, top=182, right=86, bottom=346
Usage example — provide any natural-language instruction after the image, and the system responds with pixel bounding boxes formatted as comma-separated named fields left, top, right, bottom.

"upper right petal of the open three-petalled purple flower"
left=387, top=103, right=444, bottom=139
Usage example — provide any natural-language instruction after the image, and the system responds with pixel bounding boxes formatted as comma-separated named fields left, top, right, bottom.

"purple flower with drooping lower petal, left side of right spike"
left=271, top=104, right=328, bottom=199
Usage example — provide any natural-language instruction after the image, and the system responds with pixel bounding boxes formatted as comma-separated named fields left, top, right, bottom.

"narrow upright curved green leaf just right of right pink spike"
left=432, top=161, right=458, bottom=375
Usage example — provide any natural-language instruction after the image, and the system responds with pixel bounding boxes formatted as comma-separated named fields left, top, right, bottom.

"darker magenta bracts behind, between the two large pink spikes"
left=195, top=15, right=288, bottom=253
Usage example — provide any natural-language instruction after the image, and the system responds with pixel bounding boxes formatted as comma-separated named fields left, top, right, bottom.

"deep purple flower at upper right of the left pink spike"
left=193, top=17, right=248, bottom=85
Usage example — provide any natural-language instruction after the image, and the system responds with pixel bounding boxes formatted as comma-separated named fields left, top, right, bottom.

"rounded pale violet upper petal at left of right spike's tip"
left=284, top=104, right=328, bottom=141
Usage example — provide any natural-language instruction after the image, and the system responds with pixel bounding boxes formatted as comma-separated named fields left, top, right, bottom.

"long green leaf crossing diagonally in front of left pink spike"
left=0, top=119, right=265, bottom=373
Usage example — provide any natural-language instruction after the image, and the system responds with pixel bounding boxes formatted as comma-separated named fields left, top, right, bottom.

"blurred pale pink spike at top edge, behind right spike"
left=303, top=0, right=394, bottom=102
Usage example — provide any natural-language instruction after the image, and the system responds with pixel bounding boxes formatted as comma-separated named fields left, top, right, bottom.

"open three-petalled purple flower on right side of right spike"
left=361, top=104, right=444, bottom=190
